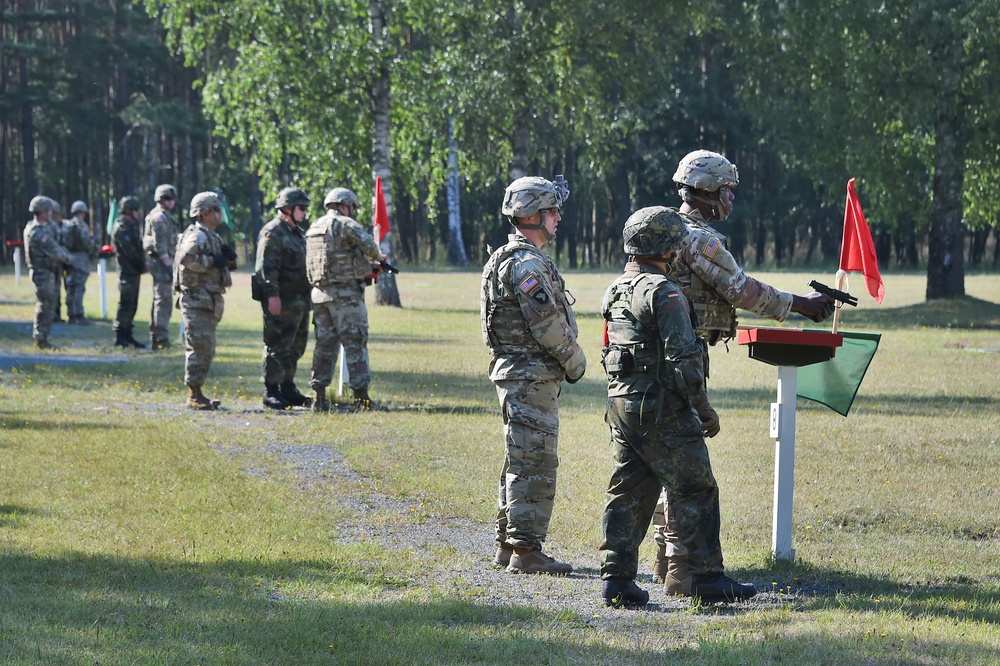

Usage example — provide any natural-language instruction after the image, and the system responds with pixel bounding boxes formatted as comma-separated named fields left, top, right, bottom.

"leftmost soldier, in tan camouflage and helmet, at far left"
left=24, top=196, right=70, bottom=349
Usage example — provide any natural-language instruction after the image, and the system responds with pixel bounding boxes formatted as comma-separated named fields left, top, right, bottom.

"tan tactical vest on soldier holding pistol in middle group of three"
left=306, top=213, right=372, bottom=287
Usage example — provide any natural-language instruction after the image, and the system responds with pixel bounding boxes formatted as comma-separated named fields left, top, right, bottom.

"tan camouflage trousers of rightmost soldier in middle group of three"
left=309, top=287, right=371, bottom=389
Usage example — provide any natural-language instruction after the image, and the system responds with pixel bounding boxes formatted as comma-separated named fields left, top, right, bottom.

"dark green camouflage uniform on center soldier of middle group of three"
left=255, top=217, right=310, bottom=384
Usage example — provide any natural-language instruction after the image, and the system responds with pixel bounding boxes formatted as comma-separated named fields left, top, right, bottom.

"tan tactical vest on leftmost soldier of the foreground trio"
left=480, top=237, right=577, bottom=356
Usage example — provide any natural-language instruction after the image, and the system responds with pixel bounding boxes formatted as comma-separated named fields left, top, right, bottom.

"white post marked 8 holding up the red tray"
left=771, top=365, right=798, bottom=561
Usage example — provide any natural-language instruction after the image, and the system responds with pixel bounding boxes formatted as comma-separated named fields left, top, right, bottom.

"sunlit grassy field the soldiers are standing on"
left=0, top=272, right=1000, bottom=665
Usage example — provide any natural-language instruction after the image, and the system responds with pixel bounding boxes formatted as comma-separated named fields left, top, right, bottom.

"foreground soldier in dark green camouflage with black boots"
left=601, top=206, right=756, bottom=606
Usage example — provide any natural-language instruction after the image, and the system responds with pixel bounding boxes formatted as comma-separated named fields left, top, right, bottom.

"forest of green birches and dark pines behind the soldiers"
left=0, top=0, right=1000, bottom=299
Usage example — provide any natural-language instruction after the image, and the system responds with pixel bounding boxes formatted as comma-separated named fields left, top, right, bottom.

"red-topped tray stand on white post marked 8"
left=737, top=328, right=844, bottom=561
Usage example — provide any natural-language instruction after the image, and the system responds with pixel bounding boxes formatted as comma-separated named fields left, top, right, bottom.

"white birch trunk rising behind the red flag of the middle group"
left=368, top=0, right=401, bottom=307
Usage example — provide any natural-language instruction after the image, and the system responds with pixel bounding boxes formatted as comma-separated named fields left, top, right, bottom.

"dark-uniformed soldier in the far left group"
left=111, top=196, right=146, bottom=349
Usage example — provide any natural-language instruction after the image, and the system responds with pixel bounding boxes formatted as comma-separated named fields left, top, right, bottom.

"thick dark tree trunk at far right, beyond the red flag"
left=927, top=111, right=965, bottom=301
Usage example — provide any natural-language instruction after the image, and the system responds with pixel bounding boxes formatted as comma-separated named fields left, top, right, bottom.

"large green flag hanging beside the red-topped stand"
left=797, top=331, right=882, bottom=416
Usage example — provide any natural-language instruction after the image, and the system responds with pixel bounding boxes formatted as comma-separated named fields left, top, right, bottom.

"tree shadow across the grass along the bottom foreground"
left=0, top=553, right=1000, bottom=665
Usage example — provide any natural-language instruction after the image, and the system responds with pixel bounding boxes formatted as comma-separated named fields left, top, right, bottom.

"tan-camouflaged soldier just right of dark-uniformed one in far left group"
left=142, top=185, right=181, bottom=350
